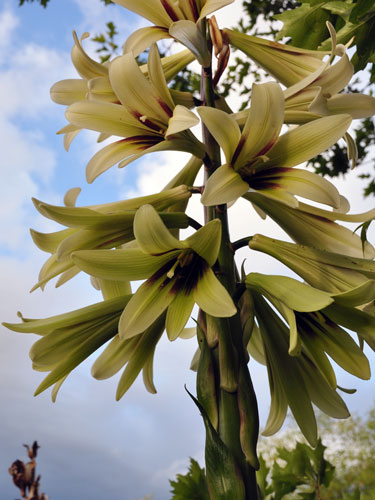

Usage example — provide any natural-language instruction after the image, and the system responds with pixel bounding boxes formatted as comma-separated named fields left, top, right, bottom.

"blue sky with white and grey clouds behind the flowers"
left=0, top=0, right=374, bottom=500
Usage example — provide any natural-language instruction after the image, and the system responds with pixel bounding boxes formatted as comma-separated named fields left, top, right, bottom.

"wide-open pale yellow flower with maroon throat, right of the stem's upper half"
left=198, top=83, right=351, bottom=208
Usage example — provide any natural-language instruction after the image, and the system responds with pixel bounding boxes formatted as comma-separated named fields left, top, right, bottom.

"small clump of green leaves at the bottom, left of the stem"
left=169, top=458, right=210, bottom=500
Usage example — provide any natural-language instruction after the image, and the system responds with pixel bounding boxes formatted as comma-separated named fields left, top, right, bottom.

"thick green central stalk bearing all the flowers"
left=197, top=25, right=259, bottom=500
